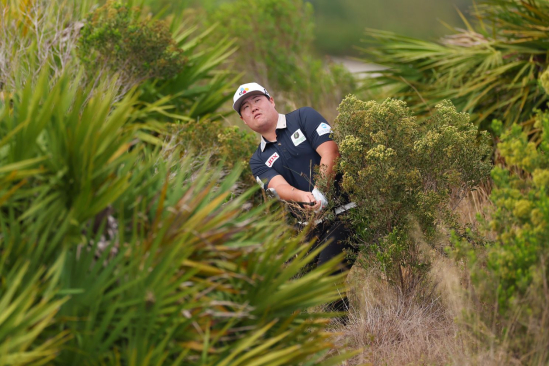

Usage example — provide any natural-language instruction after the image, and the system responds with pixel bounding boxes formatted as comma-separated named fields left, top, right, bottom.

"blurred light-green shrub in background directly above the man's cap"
left=212, top=0, right=313, bottom=91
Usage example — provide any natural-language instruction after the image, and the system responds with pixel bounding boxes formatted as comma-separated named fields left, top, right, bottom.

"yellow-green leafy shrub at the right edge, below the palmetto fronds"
left=487, top=111, right=549, bottom=309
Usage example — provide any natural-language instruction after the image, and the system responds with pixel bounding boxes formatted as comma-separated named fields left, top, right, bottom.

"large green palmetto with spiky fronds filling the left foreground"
left=0, top=62, right=356, bottom=365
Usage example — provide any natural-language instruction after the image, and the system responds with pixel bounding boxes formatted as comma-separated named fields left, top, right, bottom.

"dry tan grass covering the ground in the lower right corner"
left=332, top=255, right=549, bottom=366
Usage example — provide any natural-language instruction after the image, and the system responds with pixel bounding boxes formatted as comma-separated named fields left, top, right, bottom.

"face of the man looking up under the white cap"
left=240, top=95, right=278, bottom=133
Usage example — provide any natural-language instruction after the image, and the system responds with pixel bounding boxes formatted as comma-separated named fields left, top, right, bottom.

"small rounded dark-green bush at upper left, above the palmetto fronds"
left=78, top=1, right=185, bottom=83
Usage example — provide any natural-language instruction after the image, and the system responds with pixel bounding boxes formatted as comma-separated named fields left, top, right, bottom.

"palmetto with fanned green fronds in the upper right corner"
left=363, top=0, right=549, bottom=132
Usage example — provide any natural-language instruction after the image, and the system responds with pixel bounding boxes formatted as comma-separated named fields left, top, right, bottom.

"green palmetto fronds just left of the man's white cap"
left=135, top=18, right=237, bottom=123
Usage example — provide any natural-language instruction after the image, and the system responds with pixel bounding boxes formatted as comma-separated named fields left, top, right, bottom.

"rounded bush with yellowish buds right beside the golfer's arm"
left=333, top=96, right=491, bottom=286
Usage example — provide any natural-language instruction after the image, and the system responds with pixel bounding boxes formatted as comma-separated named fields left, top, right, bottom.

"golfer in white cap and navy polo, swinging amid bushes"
left=233, top=83, right=356, bottom=280
